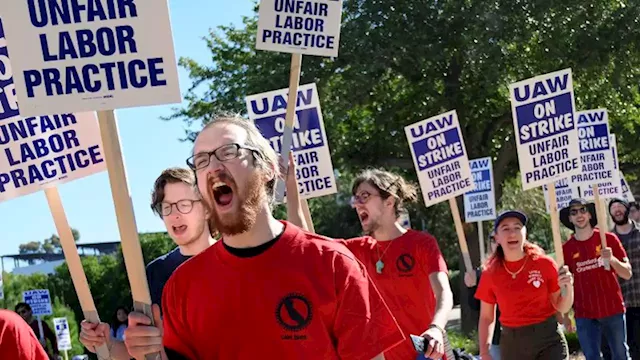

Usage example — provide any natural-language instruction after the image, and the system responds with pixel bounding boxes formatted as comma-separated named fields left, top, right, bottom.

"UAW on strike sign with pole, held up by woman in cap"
left=509, top=69, right=580, bottom=272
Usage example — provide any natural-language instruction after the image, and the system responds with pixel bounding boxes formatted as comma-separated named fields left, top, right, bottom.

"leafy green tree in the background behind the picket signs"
left=167, top=0, right=640, bottom=330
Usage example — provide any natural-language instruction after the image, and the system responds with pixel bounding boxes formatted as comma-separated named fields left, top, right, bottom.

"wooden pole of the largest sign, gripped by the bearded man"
left=98, top=110, right=160, bottom=360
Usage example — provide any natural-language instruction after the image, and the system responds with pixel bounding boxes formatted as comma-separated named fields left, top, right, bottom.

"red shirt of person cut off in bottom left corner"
left=0, top=309, right=49, bottom=360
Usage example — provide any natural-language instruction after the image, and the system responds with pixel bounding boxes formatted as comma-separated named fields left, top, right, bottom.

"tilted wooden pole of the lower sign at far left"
left=44, top=187, right=110, bottom=359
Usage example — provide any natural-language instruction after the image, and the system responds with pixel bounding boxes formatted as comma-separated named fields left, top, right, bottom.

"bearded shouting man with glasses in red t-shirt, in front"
left=125, top=117, right=404, bottom=360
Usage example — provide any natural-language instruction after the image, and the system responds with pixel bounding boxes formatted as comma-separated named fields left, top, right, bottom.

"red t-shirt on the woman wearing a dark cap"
left=476, top=255, right=560, bottom=328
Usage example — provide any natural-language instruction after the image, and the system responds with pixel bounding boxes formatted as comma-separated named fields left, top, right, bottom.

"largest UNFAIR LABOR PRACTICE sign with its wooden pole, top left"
left=0, top=0, right=181, bottom=359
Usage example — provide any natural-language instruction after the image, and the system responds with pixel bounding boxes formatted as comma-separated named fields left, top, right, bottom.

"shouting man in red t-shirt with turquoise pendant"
left=347, top=170, right=453, bottom=360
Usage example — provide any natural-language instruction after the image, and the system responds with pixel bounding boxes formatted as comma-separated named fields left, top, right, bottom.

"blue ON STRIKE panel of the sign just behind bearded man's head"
left=255, top=108, right=324, bottom=153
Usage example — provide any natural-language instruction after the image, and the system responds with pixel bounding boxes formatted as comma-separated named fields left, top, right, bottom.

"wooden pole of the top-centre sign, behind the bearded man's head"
left=276, top=53, right=315, bottom=232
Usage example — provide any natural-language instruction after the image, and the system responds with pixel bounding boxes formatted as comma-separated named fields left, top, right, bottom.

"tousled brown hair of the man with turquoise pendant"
left=351, top=169, right=418, bottom=216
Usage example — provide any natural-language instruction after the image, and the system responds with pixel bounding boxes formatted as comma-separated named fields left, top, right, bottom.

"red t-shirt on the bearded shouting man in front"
left=162, top=222, right=404, bottom=360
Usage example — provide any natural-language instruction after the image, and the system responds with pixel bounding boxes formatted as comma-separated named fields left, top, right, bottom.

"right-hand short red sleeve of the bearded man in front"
left=333, top=253, right=404, bottom=360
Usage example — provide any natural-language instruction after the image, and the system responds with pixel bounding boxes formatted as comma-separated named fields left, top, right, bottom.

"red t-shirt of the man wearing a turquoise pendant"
left=346, top=230, right=448, bottom=360
